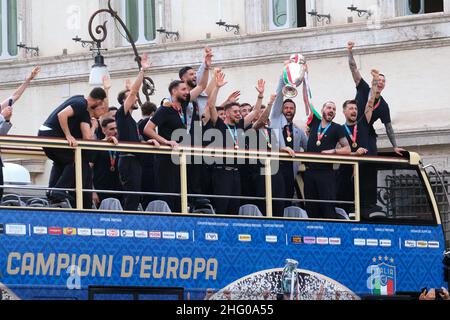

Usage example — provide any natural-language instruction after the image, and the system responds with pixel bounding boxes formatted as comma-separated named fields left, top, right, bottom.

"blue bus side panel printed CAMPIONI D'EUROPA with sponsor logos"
left=0, top=210, right=446, bottom=299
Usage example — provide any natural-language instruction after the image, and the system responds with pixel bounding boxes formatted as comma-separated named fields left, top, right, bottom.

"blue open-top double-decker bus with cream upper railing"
left=0, top=137, right=448, bottom=300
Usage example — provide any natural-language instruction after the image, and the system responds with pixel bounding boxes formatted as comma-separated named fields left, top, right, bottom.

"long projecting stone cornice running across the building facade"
left=0, top=13, right=450, bottom=89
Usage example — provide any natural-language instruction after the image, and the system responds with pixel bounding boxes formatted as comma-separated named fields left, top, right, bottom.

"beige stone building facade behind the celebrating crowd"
left=0, top=0, right=450, bottom=205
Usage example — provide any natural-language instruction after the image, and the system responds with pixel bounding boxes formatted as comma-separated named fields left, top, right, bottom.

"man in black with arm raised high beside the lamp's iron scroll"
left=116, top=54, right=154, bottom=211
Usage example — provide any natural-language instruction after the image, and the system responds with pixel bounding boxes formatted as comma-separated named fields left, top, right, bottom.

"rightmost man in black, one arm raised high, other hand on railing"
left=347, top=42, right=406, bottom=156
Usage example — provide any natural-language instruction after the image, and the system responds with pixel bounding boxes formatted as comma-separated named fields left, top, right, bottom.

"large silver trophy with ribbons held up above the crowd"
left=283, top=54, right=306, bottom=99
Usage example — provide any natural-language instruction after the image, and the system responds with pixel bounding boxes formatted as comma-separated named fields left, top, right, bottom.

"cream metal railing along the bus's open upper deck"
left=0, top=136, right=420, bottom=221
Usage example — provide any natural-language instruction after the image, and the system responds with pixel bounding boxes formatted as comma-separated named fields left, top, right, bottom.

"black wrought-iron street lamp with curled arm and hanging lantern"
left=89, top=0, right=155, bottom=105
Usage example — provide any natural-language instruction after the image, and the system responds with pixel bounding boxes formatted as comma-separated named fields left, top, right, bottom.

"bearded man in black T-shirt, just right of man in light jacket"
left=305, top=101, right=351, bottom=219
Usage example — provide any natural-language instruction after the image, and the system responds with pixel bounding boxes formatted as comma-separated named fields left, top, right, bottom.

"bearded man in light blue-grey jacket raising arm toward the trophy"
left=270, top=77, right=308, bottom=207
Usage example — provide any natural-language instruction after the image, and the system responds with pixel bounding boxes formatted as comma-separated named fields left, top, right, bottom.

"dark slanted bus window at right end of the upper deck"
left=360, top=163, right=434, bottom=223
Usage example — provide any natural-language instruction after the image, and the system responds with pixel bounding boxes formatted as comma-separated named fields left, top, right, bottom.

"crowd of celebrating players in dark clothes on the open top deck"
left=0, top=42, right=405, bottom=219
